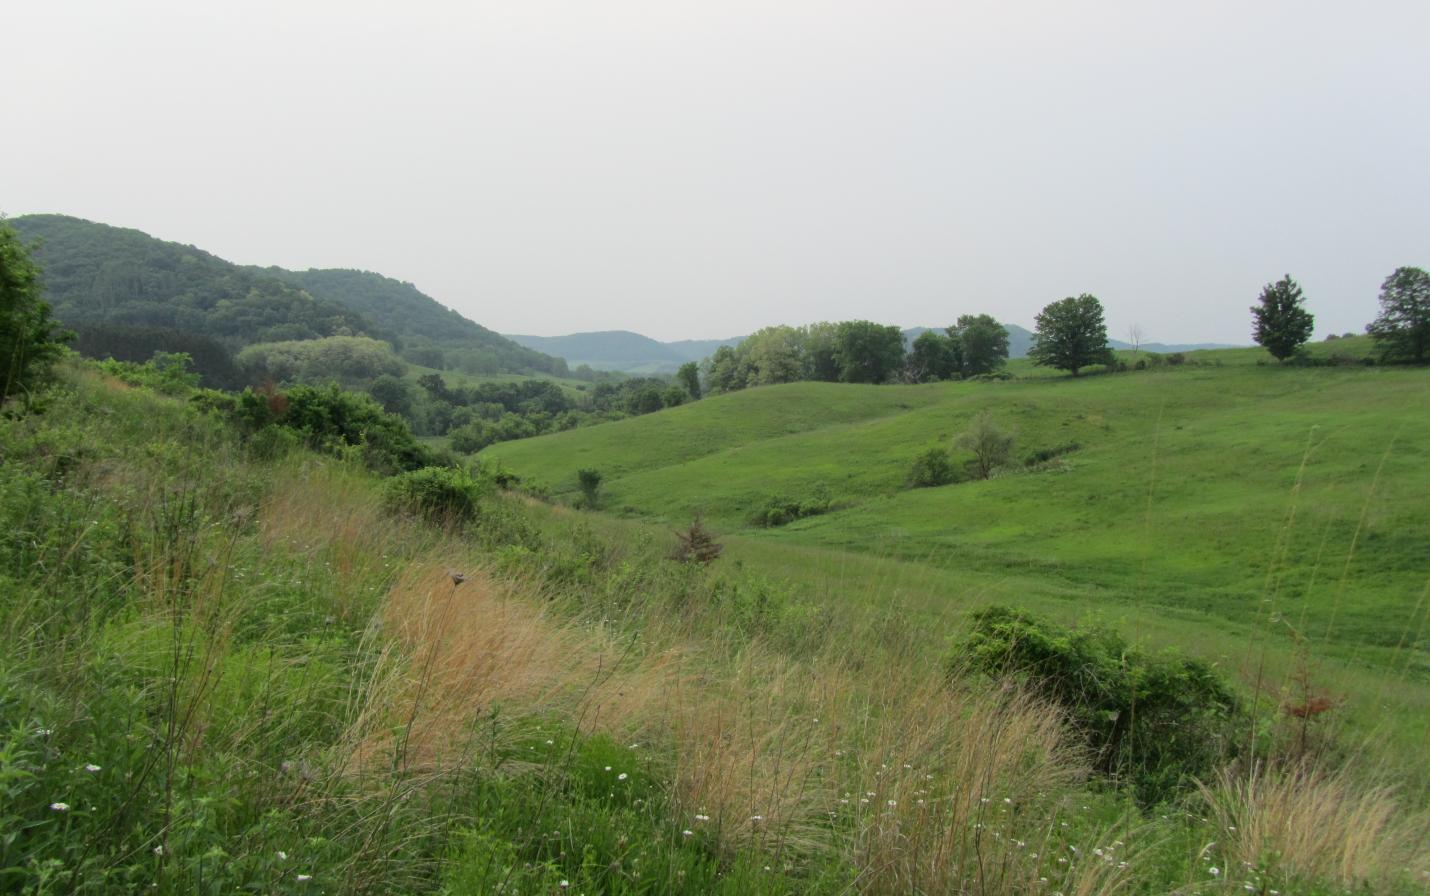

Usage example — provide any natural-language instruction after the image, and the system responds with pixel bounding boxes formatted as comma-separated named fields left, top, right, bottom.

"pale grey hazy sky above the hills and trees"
left=0, top=0, right=1430, bottom=343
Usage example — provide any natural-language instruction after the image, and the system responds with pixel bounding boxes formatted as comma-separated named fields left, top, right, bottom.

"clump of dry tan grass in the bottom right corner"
left=1201, top=765, right=1430, bottom=890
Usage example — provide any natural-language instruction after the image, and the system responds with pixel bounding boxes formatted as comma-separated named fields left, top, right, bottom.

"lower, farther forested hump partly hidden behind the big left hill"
left=252, top=267, right=568, bottom=376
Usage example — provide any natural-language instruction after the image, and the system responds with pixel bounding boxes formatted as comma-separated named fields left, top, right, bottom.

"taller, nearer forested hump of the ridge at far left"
left=10, top=214, right=385, bottom=347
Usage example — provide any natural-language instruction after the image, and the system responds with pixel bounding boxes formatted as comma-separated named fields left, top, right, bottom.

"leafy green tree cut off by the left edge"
left=0, top=220, right=69, bottom=404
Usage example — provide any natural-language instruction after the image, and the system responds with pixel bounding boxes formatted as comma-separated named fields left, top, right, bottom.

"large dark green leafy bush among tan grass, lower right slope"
left=950, top=606, right=1243, bottom=805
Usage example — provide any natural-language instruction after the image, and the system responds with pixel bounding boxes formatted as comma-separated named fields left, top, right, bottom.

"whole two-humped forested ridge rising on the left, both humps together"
left=10, top=214, right=566, bottom=374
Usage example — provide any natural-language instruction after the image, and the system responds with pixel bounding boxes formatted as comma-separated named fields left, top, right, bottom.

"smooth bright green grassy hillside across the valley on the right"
left=489, top=364, right=1430, bottom=676
